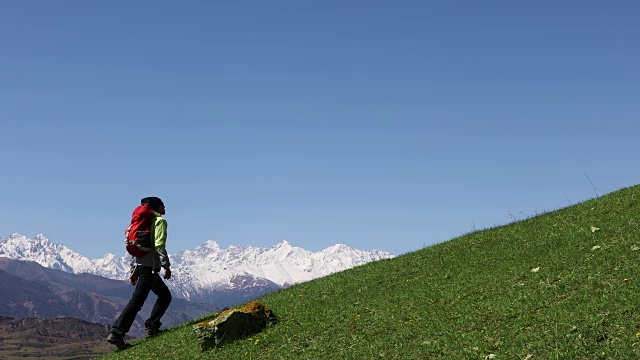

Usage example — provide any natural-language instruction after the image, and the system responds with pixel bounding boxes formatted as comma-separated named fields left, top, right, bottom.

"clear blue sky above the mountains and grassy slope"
left=0, top=0, right=640, bottom=258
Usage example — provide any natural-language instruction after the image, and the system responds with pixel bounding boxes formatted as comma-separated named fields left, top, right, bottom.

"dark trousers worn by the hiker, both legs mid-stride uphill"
left=111, top=266, right=171, bottom=336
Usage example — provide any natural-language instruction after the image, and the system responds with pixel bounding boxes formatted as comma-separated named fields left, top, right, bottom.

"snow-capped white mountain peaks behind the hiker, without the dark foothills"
left=0, top=234, right=393, bottom=303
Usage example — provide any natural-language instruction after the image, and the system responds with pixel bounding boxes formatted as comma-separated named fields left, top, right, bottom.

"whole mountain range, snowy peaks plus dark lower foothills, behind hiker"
left=0, top=234, right=393, bottom=325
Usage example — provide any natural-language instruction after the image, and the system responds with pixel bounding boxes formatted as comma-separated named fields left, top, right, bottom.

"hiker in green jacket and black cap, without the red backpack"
left=107, top=197, right=171, bottom=349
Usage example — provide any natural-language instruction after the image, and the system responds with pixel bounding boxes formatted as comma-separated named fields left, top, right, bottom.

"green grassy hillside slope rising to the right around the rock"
left=96, top=186, right=640, bottom=360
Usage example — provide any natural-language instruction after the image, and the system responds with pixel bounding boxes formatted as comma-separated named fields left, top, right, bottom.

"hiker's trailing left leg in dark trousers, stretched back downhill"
left=111, top=266, right=158, bottom=337
